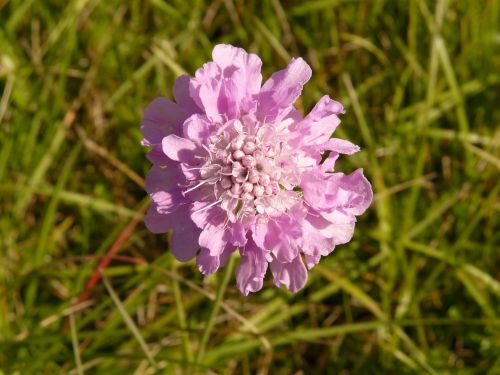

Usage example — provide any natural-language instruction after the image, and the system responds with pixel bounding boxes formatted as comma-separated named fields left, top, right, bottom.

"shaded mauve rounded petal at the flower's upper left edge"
left=141, top=98, right=187, bottom=144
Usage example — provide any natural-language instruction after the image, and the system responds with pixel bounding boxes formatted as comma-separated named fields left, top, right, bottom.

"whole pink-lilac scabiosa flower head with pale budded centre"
left=141, top=45, right=372, bottom=295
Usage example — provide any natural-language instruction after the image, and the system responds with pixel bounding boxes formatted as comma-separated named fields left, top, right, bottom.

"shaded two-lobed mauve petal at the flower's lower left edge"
left=144, top=203, right=200, bottom=262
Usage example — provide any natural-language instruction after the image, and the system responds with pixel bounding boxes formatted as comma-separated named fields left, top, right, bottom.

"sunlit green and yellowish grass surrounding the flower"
left=0, top=0, right=500, bottom=375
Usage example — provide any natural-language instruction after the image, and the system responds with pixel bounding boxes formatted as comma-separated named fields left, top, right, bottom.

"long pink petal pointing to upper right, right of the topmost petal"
left=258, top=57, right=312, bottom=120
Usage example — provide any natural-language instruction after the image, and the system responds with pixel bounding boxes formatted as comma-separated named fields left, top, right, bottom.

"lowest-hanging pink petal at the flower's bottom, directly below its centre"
left=236, top=239, right=267, bottom=296
